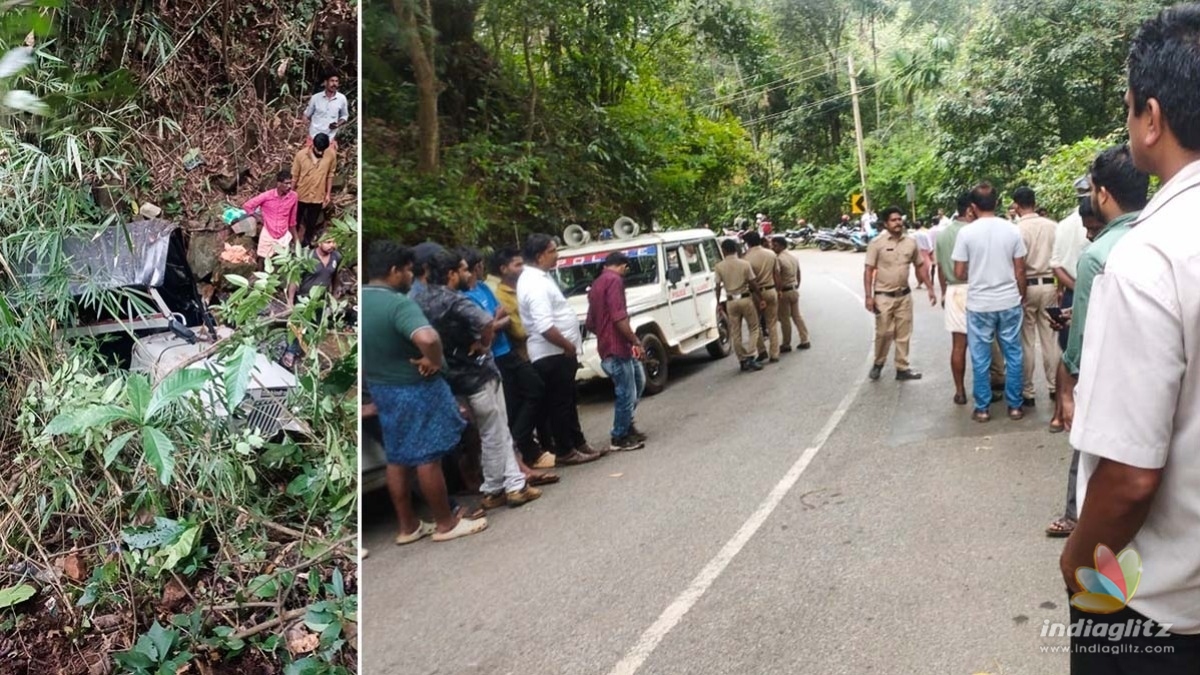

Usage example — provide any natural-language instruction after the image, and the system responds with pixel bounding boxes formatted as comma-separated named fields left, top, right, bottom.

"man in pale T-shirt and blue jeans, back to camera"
left=950, top=183, right=1026, bottom=422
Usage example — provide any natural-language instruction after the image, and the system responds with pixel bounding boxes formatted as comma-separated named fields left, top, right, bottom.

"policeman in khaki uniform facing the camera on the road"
left=863, top=207, right=937, bottom=380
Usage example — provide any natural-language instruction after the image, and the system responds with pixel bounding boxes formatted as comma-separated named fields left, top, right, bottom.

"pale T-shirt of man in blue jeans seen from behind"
left=950, top=216, right=1025, bottom=312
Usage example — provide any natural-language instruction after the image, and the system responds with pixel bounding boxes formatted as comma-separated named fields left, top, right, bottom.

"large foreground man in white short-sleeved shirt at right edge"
left=1060, top=4, right=1200, bottom=675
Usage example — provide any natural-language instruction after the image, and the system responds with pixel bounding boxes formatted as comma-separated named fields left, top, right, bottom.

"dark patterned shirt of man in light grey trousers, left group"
left=416, top=283, right=500, bottom=396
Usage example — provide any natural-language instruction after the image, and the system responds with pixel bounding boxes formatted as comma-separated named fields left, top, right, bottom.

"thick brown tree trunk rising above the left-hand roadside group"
left=392, top=0, right=439, bottom=173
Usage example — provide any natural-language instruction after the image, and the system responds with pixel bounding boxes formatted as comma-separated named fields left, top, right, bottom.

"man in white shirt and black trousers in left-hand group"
left=517, top=234, right=605, bottom=465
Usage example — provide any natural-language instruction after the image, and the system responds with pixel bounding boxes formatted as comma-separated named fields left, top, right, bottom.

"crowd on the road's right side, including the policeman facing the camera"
left=864, top=4, right=1200, bottom=673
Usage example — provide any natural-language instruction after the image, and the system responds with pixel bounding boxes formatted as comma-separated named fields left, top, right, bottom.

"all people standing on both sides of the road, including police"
left=362, top=4, right=1200, bottom=674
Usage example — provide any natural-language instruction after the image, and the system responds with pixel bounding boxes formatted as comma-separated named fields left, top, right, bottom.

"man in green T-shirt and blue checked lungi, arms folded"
left=359, top=241, right=487, bottom=544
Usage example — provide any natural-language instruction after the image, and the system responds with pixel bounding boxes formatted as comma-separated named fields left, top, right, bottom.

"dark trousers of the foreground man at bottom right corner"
left=1070, top=598, right=1200, bottom=675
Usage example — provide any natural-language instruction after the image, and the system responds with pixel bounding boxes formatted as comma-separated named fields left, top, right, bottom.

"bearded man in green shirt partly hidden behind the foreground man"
left=1046, top=145, right=1150, bottom=537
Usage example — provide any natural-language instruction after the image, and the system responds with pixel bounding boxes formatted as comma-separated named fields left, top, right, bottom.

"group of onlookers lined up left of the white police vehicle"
left=361, top=234, right=647, bottom=544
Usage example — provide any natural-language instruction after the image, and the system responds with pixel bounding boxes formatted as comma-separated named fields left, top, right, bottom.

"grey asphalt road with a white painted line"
left=361, top=251, right=1070, bottom=675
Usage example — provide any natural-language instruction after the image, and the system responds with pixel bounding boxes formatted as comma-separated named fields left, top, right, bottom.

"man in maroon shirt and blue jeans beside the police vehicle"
left=587, top=251, right=646, bottom=452
